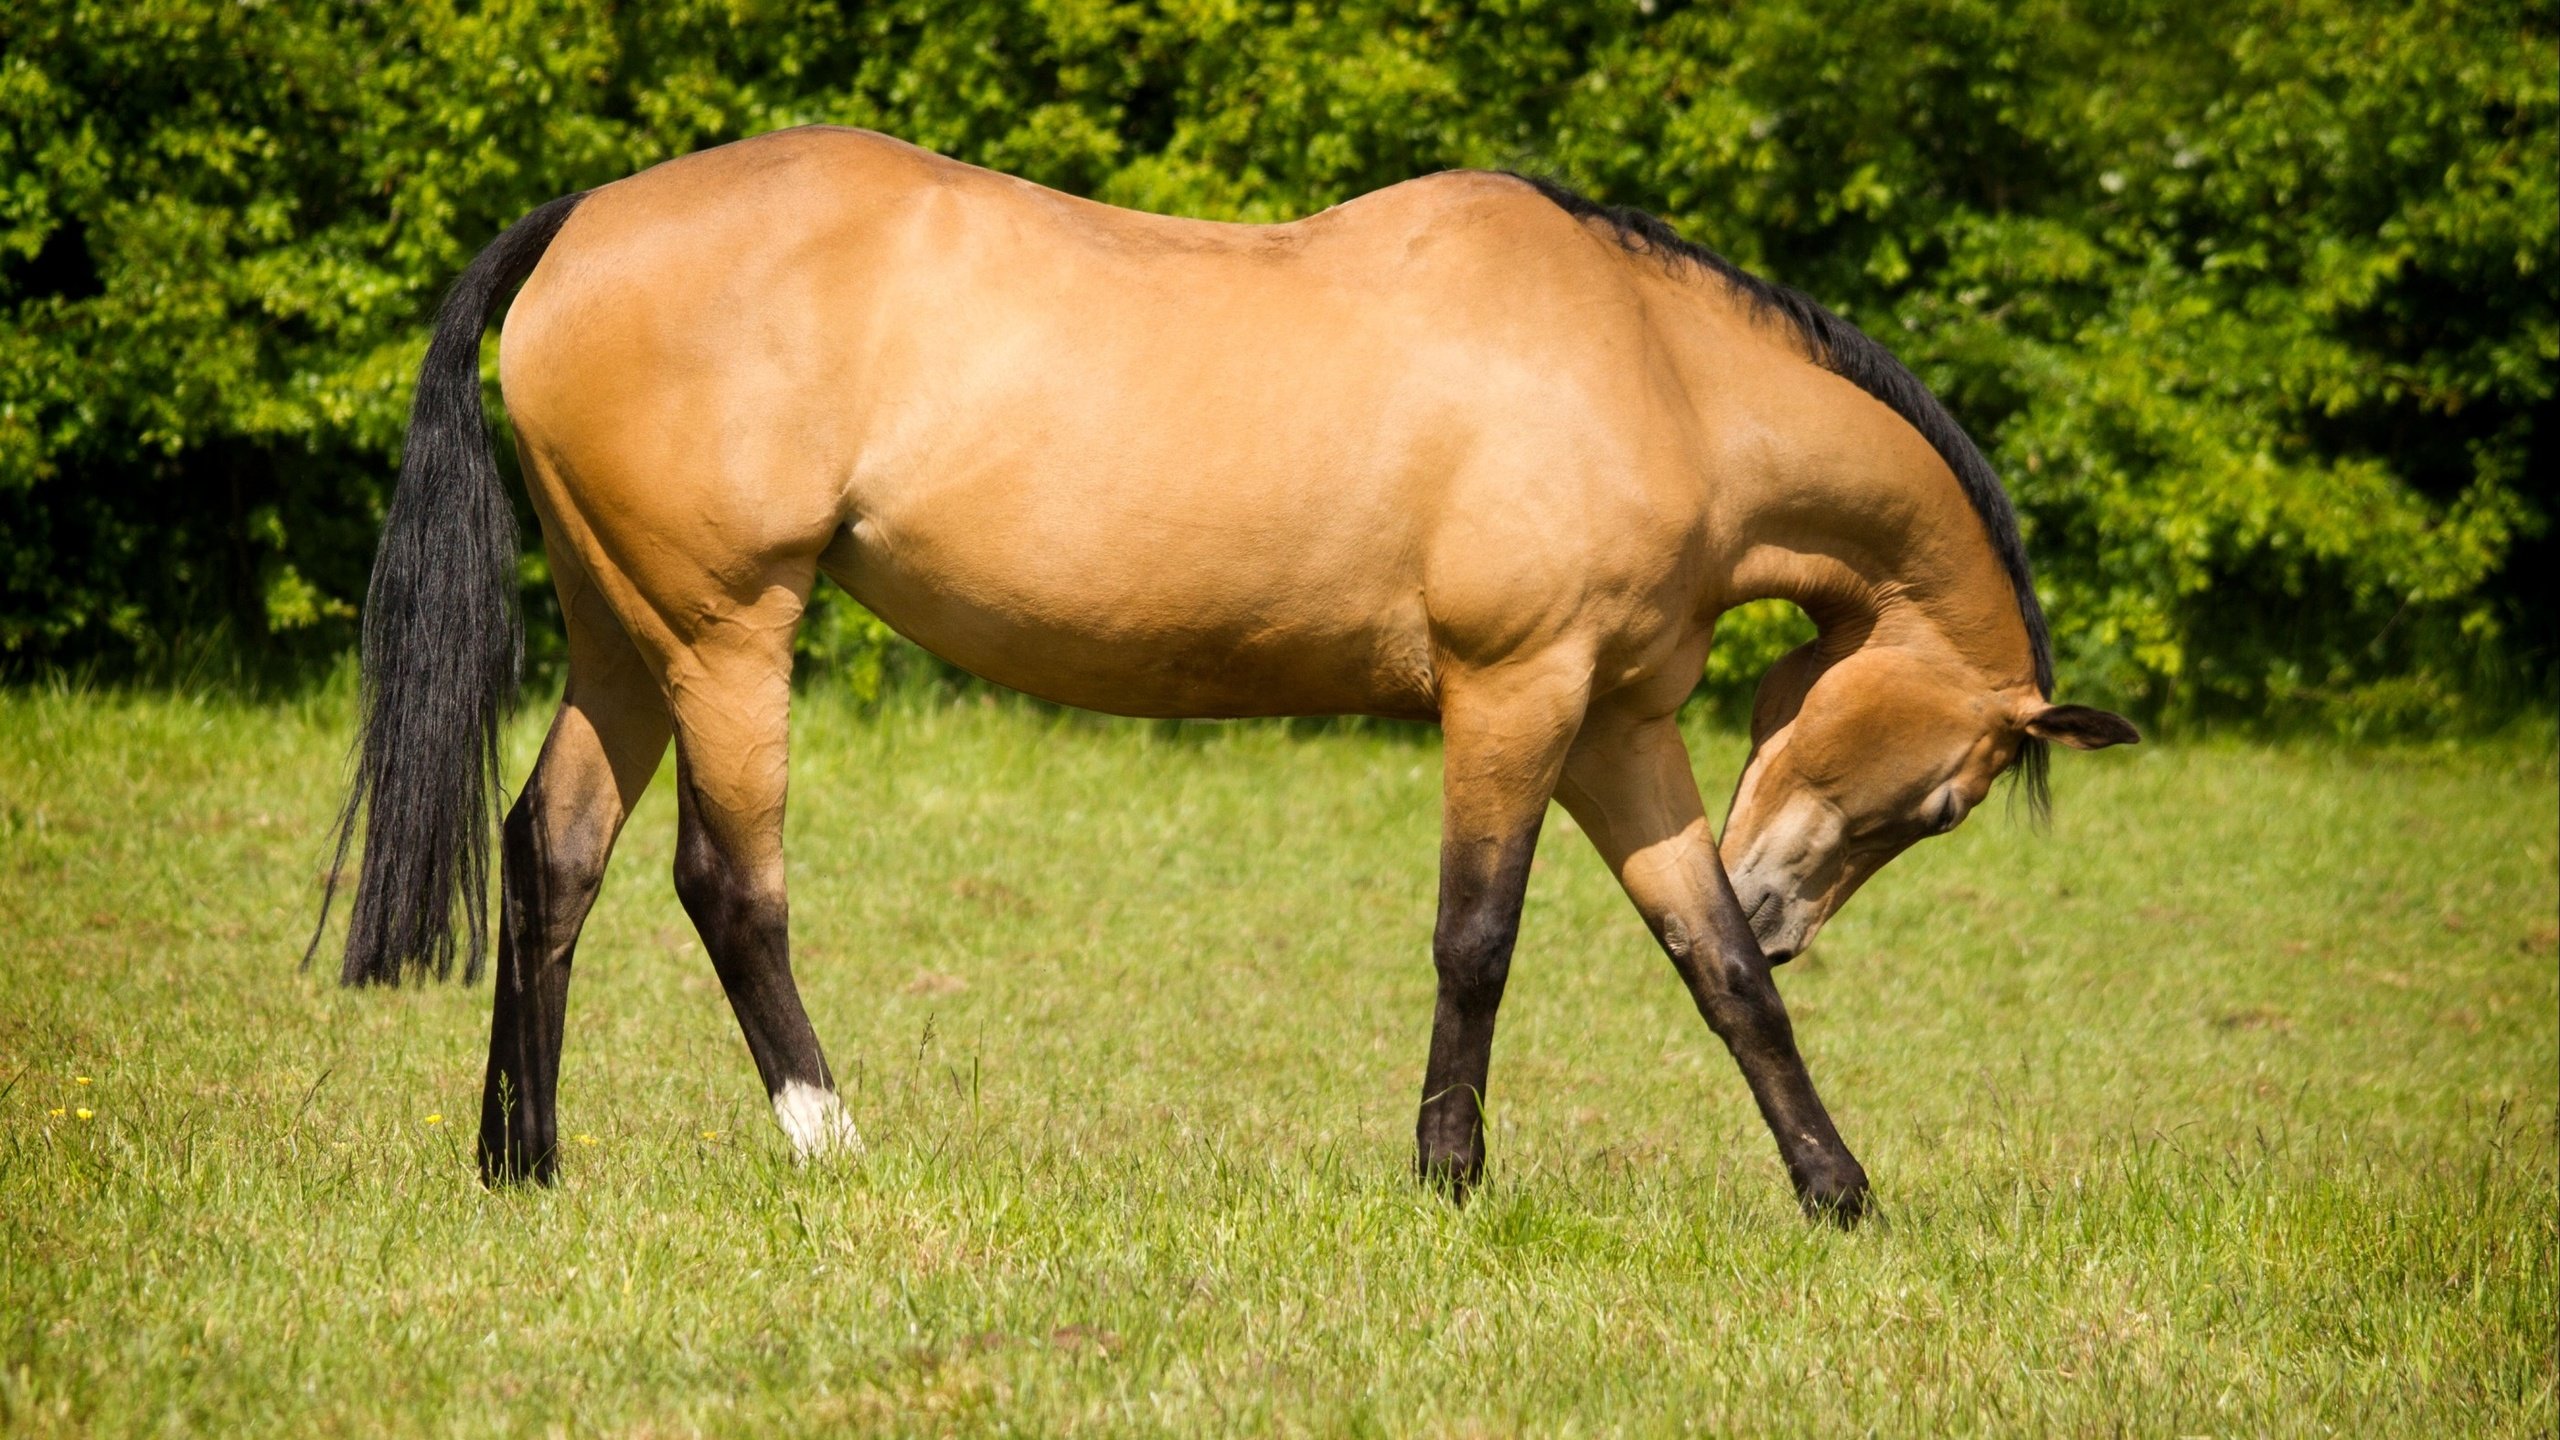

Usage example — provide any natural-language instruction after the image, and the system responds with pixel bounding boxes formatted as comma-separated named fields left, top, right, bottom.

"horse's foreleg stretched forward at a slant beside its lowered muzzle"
left=1556, top=707, right=1866, bottom=1225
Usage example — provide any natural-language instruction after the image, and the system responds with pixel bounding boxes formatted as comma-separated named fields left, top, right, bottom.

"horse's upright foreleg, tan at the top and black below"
left=1413, top=669, right=1582, bottom=1199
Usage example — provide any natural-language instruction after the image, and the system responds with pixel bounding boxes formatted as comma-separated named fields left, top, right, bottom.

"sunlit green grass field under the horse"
left=0, top=692, right=2560, bottom=1435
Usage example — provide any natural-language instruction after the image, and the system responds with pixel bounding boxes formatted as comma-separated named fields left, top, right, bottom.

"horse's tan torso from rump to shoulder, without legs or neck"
left=504, top=131, right=1710, bottom=715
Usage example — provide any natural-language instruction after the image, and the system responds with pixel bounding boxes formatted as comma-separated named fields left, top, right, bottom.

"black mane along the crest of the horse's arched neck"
left=1503, top=172, right=2053, bottom=812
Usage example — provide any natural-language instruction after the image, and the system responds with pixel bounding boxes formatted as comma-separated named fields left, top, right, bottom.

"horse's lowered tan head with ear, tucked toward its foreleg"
left=1720, top=646, right=2140, bottom=963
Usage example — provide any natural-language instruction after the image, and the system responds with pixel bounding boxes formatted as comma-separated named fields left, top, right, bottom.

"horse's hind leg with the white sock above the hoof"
left=671, top=592, right=855, bottom=1156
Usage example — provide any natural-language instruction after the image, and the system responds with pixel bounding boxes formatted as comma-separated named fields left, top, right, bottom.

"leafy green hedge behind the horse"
left=0, top=0, right=2560, bottom=725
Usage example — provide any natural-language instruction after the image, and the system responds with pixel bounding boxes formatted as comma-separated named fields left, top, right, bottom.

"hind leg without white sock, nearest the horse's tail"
left=479, top=591, right=668, bottom=1184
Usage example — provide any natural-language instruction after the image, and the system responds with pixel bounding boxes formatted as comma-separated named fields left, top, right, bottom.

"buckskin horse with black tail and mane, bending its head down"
left=312, top=128, right=2138, bottom=1225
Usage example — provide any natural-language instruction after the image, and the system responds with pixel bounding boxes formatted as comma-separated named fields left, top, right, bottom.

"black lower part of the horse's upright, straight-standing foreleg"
left=1413, top=822, right=1539, bottom=1199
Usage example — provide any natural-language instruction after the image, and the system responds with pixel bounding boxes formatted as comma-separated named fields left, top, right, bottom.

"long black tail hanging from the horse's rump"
left=302, top=192, right=584, bottom=984
